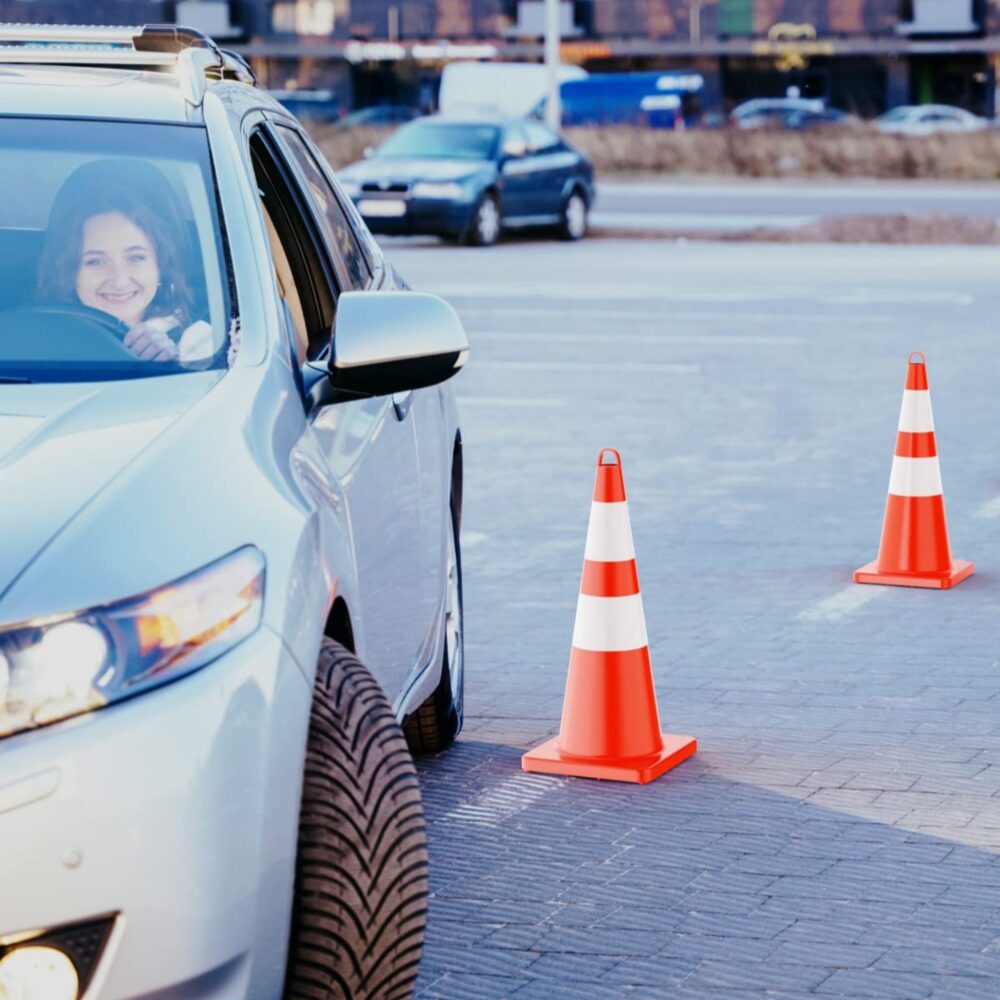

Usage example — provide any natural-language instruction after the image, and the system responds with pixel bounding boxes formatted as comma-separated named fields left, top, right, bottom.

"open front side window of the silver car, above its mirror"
left=250, top=131, right=338, bottom=364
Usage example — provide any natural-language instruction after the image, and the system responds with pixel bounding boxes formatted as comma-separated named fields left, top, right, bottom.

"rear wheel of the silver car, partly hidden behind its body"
left=403, top=494, right=465, bottom=753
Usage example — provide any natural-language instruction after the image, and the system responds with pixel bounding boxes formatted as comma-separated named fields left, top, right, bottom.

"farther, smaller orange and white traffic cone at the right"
left=854, top=351, right=974, bottom=590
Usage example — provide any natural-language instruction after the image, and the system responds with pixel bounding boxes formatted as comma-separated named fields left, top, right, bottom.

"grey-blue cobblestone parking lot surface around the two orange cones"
left=390, top=242, right=1000, bottom=1000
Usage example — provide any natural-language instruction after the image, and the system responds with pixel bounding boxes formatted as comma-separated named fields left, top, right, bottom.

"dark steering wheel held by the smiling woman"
left=0, top=302, right=138, bottom=361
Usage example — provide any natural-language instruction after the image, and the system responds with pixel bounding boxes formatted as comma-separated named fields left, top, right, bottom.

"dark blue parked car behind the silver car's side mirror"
left=340, top=115, right=594, bottom=246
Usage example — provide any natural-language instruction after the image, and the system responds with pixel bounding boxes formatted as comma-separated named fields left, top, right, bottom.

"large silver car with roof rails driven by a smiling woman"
left=0, top=26, right=468, bottom=1000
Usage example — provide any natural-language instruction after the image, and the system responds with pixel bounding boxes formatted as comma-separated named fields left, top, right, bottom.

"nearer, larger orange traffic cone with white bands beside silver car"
left=521, top=448, right=698, bottom=784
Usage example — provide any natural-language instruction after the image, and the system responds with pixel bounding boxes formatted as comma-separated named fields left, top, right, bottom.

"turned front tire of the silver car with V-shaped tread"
left=285, top=639, right=427, bottom=1000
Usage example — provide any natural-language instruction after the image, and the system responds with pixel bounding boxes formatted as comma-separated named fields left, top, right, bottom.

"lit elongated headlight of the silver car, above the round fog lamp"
left=0, top=546, right=264, bottom=738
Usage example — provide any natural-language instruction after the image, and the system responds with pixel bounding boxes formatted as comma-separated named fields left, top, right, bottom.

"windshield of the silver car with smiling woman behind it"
left=0, top=116, right=231, bottom=383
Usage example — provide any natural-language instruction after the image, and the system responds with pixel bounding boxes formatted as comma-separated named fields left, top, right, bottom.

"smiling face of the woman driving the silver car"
left=76, top=212, right=160, bottom=326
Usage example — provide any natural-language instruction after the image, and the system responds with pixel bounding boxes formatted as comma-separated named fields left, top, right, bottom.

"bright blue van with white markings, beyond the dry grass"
left=533, top=71, right=705, bottom=128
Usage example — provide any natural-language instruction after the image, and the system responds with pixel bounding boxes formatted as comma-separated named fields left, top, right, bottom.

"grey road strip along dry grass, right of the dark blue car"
left=592, top=178, right=1000, bottom=232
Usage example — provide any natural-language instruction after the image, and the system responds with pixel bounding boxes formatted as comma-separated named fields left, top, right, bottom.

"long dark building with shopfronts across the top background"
left=0, top=0, right=1000, bottom=115
